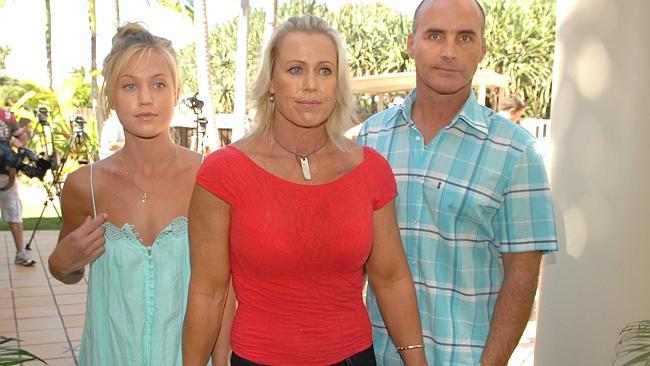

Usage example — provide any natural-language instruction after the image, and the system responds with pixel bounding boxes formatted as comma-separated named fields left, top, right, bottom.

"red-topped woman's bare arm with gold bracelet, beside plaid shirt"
left=368, top=201, right=427, bottom=365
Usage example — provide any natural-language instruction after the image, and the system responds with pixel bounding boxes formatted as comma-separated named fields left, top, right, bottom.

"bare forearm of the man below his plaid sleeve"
left=481, top=252, right=542, bottom=366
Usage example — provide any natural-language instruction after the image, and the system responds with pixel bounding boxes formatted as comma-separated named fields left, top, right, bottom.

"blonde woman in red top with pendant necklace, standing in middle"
left=183, top=15, right=426, bottom=366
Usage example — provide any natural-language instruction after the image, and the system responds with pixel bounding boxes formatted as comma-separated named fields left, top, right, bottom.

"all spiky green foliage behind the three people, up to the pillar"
left=179, top=0, right=556, bottom=118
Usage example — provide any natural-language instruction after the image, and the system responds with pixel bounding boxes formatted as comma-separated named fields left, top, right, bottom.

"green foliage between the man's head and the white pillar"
left=482, top=0, right=556, bottom=118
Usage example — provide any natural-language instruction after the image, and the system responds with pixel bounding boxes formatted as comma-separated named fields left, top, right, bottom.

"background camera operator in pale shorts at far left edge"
left=0, top=105, right=36, bottom=267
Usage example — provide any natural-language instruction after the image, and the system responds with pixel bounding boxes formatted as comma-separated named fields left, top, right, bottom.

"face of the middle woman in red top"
left=270, top=32, right=338, bottom=128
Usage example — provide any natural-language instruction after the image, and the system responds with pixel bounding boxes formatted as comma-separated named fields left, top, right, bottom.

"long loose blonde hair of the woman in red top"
left=247, top=15, right=355, bottom=151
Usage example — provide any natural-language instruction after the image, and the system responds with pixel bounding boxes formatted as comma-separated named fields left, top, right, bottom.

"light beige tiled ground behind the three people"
left=0, top=227, right=536, bottom=366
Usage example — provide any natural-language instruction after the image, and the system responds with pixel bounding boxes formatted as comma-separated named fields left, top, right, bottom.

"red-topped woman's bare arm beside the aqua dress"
left=183, top=186, right=230, bottom=366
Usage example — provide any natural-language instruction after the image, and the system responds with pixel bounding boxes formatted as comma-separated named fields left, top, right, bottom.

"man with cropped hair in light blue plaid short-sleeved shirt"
left=358, top=0, right=557, bottom=366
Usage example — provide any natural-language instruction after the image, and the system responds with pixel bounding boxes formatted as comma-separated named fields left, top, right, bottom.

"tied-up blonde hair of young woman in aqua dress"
left=100, top=23, right=181, bottom=112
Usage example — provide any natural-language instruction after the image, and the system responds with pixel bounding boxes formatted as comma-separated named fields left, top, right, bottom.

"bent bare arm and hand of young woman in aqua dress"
left=48, top=170, right=107, bottom=284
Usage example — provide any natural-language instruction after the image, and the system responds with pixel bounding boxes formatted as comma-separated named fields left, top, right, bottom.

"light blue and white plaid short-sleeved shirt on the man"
left=358, top=90, right=557, bottom=366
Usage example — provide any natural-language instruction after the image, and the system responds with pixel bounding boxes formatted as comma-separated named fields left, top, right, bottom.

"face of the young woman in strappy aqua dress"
left=113, top=51, right=178, bottom=138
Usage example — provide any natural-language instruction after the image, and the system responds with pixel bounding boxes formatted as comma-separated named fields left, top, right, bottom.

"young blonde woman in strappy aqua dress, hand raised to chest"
left=49, top=23, right=234, bottom=366
